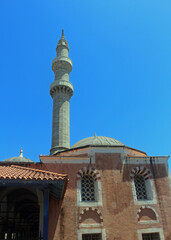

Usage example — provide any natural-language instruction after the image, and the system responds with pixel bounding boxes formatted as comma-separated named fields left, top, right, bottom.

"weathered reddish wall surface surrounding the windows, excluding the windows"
left=33, top=149, right=171, bottom=240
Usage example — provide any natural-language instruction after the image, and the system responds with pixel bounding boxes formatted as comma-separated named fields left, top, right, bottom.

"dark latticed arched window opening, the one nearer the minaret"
left=81, top=174, right=96, bottom=202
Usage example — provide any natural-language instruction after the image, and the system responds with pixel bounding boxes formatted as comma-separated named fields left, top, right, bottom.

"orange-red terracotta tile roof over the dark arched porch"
left=0, top=165, right=67, bottom=180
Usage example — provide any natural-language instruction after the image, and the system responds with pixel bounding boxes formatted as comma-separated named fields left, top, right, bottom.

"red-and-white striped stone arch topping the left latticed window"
left=77, top=167, right=101, bottom=181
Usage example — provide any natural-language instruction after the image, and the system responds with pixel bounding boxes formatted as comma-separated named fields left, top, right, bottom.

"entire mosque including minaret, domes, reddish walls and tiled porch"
left=0, top=32, right=171, bottom=240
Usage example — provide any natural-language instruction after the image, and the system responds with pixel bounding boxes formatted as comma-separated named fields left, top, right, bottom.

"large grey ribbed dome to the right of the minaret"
left=71, top=136, right=125, bottom=148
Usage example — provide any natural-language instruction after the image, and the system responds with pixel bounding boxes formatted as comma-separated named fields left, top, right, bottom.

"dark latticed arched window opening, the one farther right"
left=134, top=174, right=147, bottom=200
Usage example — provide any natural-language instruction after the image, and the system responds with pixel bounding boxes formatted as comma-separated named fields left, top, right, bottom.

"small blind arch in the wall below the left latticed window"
left=79, top=207, right=103, bottom=224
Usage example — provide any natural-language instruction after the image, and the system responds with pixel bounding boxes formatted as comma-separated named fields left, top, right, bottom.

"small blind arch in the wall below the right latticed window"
left=137, top=206, right=158, bottom=223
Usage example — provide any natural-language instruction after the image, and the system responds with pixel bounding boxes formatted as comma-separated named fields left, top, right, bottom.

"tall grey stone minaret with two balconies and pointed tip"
left=50, top=30, right=73, bottom=155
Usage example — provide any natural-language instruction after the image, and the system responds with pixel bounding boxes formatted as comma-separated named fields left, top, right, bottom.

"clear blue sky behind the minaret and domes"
left=0, top=0, right=171, bottom=167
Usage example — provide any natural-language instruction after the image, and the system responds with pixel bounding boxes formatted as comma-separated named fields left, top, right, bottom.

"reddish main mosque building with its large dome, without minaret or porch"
left=40, top=136, right=171, bottom=240
